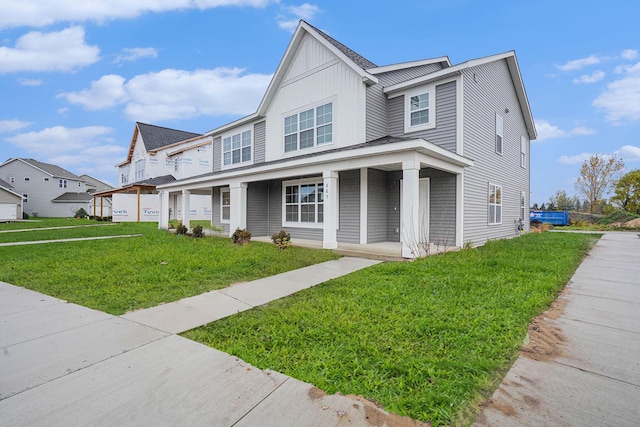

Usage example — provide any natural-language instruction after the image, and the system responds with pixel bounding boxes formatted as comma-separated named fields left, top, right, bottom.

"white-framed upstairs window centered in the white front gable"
left=282, top=100, right=336, bottom=154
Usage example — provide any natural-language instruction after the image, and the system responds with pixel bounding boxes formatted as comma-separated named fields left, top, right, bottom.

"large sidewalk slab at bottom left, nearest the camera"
left=0, top=335, right=295, bottom=426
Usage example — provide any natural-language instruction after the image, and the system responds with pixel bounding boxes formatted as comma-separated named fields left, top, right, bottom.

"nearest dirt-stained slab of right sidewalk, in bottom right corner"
left=474, top=357, right=640, bottom=427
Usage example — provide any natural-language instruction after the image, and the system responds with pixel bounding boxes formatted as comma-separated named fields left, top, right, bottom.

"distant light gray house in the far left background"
left=0, top=158, right=91, bottom=217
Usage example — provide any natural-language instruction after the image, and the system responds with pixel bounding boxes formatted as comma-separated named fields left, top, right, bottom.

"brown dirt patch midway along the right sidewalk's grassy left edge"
left=520, top=291, right=568, bottom=362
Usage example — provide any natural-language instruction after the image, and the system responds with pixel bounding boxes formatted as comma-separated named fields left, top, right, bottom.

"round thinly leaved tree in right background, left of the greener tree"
left=576, top=153, right=624, bottom=213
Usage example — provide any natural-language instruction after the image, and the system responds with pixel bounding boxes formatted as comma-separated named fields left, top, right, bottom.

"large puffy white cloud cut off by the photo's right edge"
left=593, top=62, right=640, bottom=125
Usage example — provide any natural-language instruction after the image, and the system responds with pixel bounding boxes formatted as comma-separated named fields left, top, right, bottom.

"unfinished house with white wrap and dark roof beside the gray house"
left=105, top=122, right=213, bottom=221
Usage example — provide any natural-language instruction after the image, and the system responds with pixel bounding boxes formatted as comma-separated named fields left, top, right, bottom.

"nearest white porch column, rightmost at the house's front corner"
left=400, top=161, right=420, bottom=258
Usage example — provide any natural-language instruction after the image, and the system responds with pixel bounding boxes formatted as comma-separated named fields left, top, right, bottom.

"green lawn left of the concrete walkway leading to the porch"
left=0, top=222, right=338, bottom=315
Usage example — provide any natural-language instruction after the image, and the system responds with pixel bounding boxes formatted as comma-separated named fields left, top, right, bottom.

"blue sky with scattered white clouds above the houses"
left=0, top=0, right=640, bottom=203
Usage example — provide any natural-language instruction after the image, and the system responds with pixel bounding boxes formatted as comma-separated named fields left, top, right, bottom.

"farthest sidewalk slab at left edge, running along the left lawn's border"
left=0, top=296, right=111, bottom=348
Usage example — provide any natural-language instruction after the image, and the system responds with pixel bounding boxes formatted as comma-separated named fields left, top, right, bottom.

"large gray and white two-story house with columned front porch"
left=155, top=21, right=536, bottom=258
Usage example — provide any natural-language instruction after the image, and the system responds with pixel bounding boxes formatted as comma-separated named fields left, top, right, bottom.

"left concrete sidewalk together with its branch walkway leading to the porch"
left=0, top=258, right=430, bottom=426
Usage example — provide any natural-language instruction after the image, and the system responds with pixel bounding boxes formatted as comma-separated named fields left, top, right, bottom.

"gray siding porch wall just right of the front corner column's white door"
left=420, top=168, right=457, bottom=246
